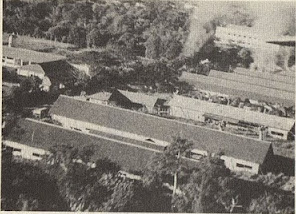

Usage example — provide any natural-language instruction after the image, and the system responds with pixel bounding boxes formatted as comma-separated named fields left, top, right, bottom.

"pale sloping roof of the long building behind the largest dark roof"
left=168, top=95, right=295, bottom=131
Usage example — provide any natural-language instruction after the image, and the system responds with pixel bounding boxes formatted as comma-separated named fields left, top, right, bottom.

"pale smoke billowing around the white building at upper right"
left=183, top=1, right=295, bottom=70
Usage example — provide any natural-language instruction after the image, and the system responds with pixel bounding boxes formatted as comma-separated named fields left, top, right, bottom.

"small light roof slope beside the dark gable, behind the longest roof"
left=118, top=90, right=158, bottom=107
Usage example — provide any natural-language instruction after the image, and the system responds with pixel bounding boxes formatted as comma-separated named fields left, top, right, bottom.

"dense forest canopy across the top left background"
left=4, top=1, right=188, bottom=58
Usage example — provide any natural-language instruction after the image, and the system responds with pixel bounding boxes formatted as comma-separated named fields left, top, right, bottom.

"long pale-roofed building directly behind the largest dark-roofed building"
left=168, top=95, right=295, bottom=140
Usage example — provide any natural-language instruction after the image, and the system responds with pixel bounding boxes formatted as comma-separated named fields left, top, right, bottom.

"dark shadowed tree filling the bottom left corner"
left=1, top=147, right=68, bottom=211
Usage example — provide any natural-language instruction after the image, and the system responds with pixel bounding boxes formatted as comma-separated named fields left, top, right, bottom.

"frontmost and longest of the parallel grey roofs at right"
left=180, top=72, right=295, bottom=106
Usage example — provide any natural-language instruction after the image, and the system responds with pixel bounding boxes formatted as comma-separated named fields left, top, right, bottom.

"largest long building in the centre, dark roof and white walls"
left=50, top=95, right=273, bottom=173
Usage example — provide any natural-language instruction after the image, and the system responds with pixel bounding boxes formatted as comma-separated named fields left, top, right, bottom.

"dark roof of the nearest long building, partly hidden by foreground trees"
left=10, top=120, right=155, bottom=171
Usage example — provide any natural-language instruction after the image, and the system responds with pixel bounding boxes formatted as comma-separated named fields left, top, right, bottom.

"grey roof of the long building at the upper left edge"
left=2, top=46, right=66, bottom=63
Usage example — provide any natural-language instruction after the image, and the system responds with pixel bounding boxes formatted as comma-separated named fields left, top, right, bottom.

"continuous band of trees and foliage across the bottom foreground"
left=1, top=138, right=294, bottom=213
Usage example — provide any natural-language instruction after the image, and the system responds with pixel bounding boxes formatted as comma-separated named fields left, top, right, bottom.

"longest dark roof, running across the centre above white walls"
left=50, top=95, right=271, bottom=164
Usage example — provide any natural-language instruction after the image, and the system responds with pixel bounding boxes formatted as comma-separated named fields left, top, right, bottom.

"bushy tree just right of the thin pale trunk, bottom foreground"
left=173, top=157, right=239, bottom=213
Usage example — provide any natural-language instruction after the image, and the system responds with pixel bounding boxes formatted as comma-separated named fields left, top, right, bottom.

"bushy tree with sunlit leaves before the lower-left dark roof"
left=44, top=144, right=120, bottom=211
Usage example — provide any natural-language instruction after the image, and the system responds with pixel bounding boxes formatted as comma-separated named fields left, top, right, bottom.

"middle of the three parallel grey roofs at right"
left=209, top=70, right=295, bottom=93
